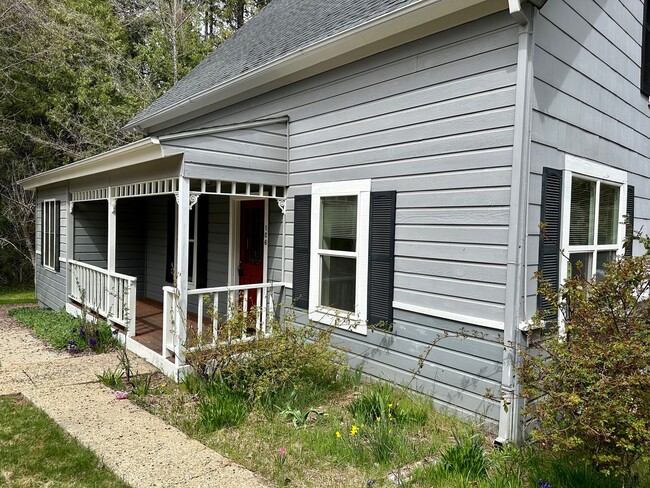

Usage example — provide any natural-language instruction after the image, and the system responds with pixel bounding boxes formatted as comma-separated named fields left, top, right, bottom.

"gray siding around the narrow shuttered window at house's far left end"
left=34, top=186, right=69, bottom=310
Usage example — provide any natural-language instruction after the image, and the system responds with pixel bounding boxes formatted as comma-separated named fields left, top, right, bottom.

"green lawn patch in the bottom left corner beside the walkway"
left=0, top=395, right=129, bottom=488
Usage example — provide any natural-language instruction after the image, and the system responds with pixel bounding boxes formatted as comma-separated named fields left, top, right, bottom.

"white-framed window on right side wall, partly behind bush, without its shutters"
left=560, top=156, right=627, bottom=281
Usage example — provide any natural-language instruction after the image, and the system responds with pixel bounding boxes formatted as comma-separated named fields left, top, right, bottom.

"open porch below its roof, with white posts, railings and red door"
left=68, top=177, right=285, bottom=376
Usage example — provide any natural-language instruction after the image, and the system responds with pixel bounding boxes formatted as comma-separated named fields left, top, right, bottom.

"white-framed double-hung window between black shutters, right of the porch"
left=309, top=180, right=370, bottom=333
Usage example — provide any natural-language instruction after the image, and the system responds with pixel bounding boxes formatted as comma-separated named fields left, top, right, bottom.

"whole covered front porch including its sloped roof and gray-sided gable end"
left=59, top=119, right=287, bottom=377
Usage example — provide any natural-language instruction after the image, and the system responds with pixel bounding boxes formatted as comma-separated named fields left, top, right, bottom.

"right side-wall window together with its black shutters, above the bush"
left=537, top=155, right=634, bottom=328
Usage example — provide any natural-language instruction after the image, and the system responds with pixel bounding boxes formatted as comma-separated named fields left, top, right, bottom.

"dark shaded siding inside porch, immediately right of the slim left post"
left=115, top=198, right=148, bottom=296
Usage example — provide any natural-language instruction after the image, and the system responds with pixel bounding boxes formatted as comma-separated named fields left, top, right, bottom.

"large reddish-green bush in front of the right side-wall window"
left=519, top=255, right=650, bottom=478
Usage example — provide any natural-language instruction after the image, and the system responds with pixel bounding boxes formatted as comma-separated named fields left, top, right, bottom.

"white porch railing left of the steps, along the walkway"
left=68, top=259, right=137, bottom=337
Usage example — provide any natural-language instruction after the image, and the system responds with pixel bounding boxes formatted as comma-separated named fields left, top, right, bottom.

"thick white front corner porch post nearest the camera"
left=174, top=177, right=190, bottom=366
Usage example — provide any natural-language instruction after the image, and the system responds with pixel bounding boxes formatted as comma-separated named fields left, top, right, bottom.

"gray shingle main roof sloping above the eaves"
left=129, top=0, right=410, bottom=129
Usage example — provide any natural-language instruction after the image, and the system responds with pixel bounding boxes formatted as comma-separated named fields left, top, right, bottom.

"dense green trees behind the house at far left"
left=0, top=0, right=268, bottom=280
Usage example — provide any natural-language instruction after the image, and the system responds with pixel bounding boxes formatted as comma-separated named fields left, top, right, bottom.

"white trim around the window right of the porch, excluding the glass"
left=309, top=179, right=371, bottom=334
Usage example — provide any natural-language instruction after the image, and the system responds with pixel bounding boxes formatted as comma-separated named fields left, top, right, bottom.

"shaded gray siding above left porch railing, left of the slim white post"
left=73, top=200, right=108, bottom=269
